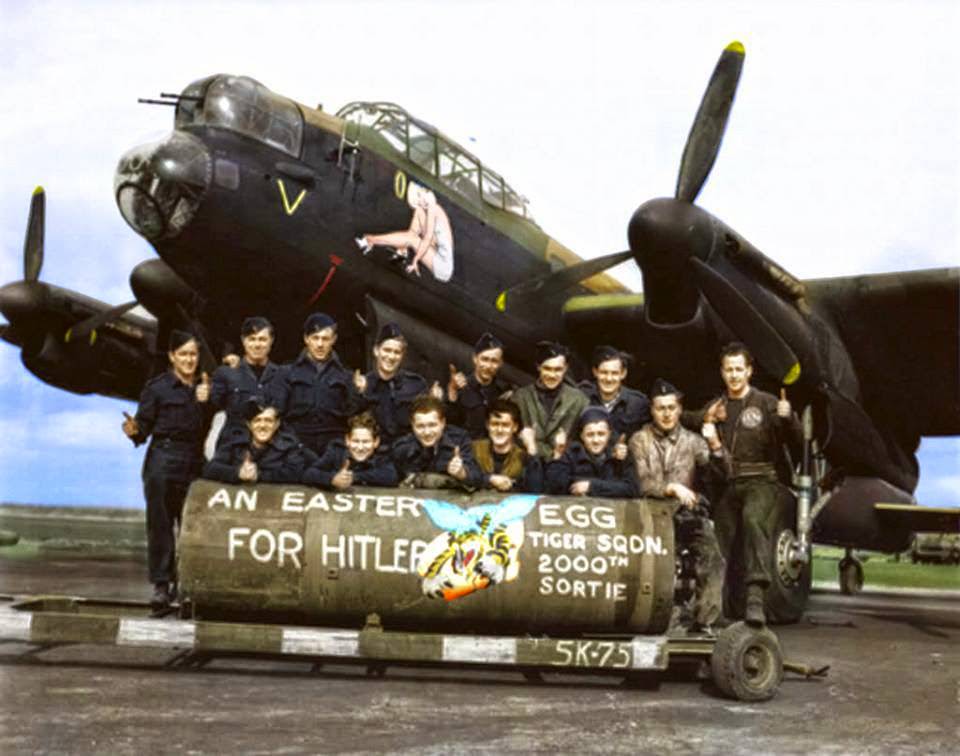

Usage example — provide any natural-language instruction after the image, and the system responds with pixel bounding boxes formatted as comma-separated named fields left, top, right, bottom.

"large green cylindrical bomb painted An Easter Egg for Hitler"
left=178, top=480, right=675, bottom=634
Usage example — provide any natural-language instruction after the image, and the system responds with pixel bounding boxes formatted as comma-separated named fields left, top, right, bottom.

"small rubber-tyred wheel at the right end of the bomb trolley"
left=710, top=622, right=783, bottom=701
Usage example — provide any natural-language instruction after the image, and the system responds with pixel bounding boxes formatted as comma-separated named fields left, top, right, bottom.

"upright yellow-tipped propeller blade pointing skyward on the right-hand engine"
left=674, top=42, right=745, bottom=202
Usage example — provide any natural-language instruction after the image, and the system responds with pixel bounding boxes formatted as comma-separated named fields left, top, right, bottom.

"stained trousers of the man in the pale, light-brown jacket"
left=673, top=504, right=727, bottom=625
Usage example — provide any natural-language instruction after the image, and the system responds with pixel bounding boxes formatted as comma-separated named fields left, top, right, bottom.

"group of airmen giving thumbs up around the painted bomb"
left=123, top=313, right=799, bottom=630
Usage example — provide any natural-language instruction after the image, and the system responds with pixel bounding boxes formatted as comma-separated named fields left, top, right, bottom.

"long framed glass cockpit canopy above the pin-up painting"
left=337, top=102, right=533, bottom=220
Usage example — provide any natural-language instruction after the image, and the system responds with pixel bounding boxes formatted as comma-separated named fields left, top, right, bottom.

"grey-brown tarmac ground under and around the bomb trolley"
left=0, top=557, right=960, bottom=754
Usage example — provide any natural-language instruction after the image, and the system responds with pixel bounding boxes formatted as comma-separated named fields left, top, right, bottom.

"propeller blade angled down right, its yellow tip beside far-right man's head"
left=690, top=257, right=800, bottom=386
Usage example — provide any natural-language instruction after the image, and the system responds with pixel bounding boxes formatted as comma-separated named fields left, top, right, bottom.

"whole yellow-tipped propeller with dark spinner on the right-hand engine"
left=496, top=42, right=802, bottom=384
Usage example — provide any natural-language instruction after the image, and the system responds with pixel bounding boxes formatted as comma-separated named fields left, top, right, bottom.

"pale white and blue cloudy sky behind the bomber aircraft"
left=0, top=0, right=960, bottom=507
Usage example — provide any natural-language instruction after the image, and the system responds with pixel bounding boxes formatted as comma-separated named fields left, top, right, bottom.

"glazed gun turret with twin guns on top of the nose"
left=175, top=74, right=303, bottom=157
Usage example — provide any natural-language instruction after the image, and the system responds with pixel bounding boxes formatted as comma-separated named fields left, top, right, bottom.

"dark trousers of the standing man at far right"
left=713, top=477, right=780, bottom=589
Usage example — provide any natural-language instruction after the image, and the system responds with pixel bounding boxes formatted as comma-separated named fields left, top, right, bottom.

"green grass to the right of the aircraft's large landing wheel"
left=813, top=546, right=960, bottom=591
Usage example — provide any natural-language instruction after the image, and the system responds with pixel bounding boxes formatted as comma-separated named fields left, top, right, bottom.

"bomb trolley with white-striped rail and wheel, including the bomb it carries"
left=0, top=481, right=789, bottom=701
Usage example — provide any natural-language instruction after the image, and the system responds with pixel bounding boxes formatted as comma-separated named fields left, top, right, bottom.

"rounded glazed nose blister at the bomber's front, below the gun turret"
left=114, top=131, right=212, bottom=241
